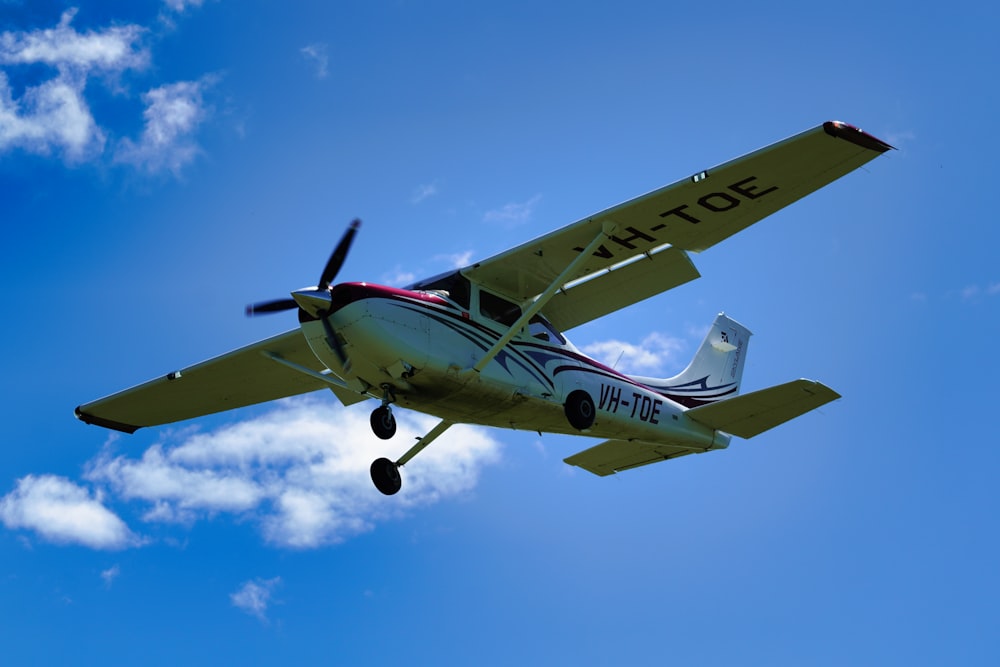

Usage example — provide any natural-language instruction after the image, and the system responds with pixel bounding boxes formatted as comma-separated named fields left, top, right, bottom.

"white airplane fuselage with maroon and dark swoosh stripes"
left=301, top=283, right=729, bottom=450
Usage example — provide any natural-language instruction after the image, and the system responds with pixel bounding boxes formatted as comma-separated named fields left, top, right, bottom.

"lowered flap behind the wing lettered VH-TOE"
left=544, top=246, right=701, bottom=331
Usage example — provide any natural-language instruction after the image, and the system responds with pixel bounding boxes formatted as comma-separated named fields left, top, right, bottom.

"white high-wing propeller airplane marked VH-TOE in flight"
left=76, top=121, right=892, bottom=495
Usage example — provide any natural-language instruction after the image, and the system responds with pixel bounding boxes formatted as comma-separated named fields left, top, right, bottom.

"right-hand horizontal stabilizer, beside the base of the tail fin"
left=687, top=380, right=840, bottom=438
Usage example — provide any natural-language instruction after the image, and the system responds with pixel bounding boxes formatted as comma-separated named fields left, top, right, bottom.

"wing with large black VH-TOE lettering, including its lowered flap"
left=463, top=121, right=892, bottom=329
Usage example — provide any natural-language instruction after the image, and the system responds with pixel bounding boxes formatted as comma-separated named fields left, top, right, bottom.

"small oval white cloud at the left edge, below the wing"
left=0, top=475, right=140, bottom=549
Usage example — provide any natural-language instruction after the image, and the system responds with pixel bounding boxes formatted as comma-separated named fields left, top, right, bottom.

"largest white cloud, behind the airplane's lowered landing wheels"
left=86, top=397, right=499, bottom=548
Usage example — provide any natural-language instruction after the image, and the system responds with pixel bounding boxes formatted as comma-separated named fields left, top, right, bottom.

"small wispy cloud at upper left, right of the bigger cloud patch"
left=115, top=76, right=215, bottom=174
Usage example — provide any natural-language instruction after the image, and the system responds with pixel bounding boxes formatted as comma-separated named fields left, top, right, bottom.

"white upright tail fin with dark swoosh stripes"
left=636, top=313, right=751, bottom=408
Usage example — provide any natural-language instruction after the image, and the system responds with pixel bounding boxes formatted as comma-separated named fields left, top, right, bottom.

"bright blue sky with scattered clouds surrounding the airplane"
left=0, top=0, right=1000, bottom=665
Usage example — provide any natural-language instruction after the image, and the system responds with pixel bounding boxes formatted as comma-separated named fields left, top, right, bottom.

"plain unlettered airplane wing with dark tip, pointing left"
left=76, top=329, right=367, bottom=433
